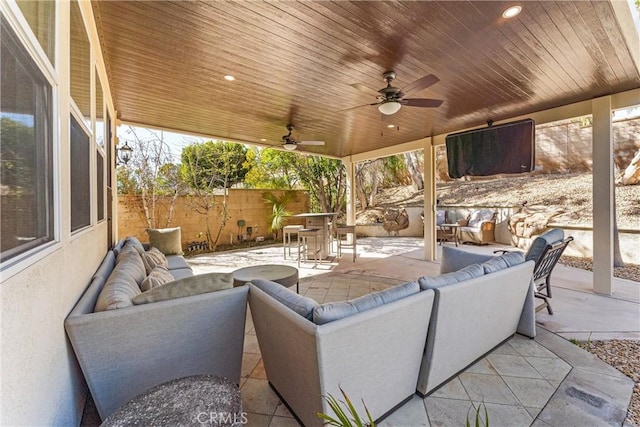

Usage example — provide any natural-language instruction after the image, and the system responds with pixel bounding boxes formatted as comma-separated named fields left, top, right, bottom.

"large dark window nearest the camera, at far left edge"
left=0, top=16, right=54, bottom=264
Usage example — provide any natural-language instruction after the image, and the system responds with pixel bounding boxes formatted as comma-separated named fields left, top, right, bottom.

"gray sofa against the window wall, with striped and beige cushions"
left=65, top=238, right=248, bottom=420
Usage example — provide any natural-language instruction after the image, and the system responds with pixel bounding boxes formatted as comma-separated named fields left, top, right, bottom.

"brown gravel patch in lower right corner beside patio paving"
left=578, top=340, right=640, bottom=426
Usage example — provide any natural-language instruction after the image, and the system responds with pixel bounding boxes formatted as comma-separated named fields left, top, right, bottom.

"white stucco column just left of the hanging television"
left=423, top=138, right=437, bottom=261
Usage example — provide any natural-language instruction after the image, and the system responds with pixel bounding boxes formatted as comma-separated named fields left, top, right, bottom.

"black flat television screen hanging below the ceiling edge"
left=446, top=119, right=536, bottom=178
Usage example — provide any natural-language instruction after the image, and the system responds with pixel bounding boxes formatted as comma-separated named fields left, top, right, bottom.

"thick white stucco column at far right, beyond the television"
left=591, top=96, right=615, bottom=295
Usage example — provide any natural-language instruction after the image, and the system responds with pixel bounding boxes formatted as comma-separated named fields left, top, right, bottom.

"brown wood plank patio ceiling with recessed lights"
left=93, top=0, right=640, bottom=157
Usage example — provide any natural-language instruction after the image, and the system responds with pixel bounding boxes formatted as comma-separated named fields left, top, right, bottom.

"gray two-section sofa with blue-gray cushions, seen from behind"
left=249, top=247, right=535, bottom=426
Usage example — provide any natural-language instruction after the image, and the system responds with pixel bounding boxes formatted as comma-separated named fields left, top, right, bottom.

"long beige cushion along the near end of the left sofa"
left=132, top=273, right=233, bottom=305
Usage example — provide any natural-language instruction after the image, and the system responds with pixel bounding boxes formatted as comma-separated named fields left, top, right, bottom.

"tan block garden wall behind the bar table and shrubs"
left=118, top=189, right=309, bottom=247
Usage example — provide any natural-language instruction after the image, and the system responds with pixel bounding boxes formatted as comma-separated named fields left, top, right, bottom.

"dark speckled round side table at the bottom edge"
left=101, top=375, right=242, bottom=427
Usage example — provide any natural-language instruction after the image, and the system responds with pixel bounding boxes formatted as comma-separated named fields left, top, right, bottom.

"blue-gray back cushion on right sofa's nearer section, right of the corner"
left=313, top=282, right=420, bottom=325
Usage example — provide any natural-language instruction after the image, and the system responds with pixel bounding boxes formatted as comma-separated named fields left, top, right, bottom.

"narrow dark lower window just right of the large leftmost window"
left=69, top=115, right=91, bottom=232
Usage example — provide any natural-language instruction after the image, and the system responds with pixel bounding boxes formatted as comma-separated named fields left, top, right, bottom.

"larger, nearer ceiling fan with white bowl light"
left=343, top=71, right=443, bottom=116
